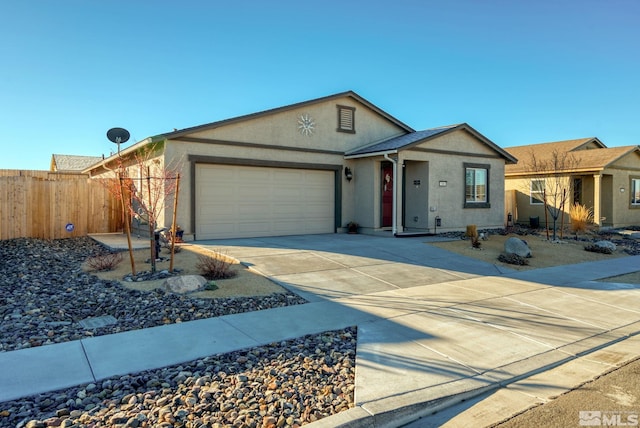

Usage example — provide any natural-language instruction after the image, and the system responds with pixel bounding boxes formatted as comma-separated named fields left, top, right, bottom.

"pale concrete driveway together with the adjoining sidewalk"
left=0, top=234, right=640, bottom=426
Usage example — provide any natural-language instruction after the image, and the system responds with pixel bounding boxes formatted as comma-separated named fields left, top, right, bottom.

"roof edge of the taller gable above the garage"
left=152, top=91, right=414, bottom=141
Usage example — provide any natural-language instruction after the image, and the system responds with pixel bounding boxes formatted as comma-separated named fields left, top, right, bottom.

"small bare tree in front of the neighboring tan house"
left=525, top=149, right=578, bottom=240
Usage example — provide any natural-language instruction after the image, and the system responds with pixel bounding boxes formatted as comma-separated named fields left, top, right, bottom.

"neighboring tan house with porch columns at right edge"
left=505, top=138, right=640, bottom=227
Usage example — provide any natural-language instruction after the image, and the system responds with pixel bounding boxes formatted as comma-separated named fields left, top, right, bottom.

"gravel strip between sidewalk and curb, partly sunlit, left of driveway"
left=0, top=328, right=356, bottom=428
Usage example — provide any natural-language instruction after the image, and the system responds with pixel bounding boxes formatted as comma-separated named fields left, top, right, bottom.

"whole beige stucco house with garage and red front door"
left=86, top=91, right=516, bottom=240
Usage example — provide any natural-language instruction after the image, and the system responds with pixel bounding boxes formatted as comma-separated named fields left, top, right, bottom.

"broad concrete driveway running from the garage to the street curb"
left=198, top=234, right=640, bottom=426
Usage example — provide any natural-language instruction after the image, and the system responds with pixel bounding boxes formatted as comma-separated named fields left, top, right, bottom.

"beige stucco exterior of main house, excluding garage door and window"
left=88, top=92, right=515, bottom=239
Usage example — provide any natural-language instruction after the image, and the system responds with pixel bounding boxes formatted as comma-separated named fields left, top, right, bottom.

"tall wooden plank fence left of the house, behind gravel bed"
left=0, top=170, right=122, bottom=240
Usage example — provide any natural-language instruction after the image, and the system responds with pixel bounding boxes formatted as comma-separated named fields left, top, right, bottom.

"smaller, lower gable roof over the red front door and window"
left=345, top=123, right=518, bottom=163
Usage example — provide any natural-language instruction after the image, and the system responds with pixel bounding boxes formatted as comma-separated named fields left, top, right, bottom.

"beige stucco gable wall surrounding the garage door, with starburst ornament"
left=159, top=97, right=404, bottom=234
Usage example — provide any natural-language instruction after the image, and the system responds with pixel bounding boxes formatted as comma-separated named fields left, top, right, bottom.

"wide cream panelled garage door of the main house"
left=196, top=165, right=334, bottom=239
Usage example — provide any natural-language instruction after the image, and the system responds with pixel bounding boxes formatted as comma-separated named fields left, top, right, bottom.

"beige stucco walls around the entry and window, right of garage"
left=354, top=130, right=506, bottom=232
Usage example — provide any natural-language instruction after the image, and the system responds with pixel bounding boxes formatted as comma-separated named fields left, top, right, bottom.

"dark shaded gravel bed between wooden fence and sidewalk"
left=0, top=238, right=306, bottom=352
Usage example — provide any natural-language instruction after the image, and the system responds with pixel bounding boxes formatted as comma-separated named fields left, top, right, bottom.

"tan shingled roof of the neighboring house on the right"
left=505, top=137, right=640, bottom=175
